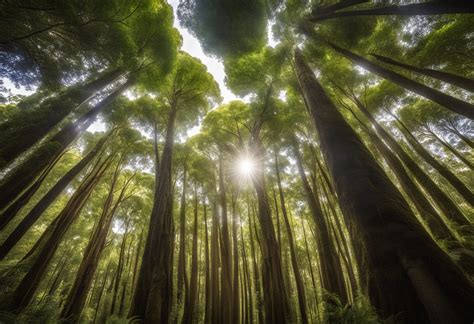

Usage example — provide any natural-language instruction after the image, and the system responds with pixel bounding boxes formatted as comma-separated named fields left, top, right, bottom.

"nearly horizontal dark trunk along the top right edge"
left=309, top=0, right=474, bottom=22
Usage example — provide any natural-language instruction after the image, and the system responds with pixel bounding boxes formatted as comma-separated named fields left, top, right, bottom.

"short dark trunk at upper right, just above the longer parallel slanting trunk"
left=370, top=54, right=474, bottom=92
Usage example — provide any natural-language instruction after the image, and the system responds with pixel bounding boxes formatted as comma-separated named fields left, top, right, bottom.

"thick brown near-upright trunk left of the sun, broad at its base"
left=128, top=104, right=176, bottom=323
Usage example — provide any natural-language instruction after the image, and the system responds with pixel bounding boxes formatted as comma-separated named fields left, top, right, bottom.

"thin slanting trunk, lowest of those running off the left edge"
left=0, top=135, right=109, bottom=260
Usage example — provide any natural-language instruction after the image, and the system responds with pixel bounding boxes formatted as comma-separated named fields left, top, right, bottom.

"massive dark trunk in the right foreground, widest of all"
left=295, top=52, right=474, bottom=323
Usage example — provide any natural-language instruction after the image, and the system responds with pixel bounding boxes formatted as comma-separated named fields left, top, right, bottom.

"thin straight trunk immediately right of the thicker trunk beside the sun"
left=275, top=151, right=308, bottom=323
